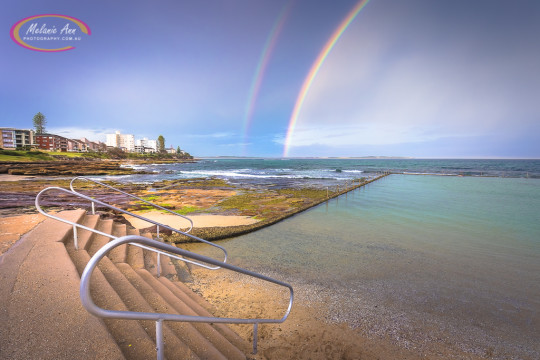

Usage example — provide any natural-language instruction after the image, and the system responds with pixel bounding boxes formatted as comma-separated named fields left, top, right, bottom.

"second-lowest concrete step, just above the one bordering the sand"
left=117, top=264, right=226, bottom=359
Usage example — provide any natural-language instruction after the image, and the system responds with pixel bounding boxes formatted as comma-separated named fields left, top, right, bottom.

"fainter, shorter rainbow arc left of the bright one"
left=244, top=2, right=292, bottom=150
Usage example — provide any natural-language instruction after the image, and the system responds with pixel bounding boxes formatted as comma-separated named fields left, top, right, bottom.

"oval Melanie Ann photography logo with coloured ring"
left=10, top=14, right=91, bottom=52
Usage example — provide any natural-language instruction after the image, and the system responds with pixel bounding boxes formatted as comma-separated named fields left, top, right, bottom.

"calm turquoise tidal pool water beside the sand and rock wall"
left=187, top=175, right=540, bottom=359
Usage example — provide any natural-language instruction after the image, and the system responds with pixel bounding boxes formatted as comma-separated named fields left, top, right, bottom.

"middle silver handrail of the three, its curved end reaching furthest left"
left=35, top=186, right=227, bottom=270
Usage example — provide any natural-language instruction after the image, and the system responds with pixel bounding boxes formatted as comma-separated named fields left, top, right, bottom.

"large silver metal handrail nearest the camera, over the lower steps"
left=79, top=235, right=294, bottom=360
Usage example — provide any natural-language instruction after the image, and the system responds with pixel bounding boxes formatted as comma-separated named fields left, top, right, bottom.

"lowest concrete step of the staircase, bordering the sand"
left=137, top=270, right=246, bottom=360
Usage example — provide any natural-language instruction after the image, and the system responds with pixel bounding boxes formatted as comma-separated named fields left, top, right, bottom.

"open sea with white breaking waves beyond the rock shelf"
left=113, top=158, right=540, bottom=187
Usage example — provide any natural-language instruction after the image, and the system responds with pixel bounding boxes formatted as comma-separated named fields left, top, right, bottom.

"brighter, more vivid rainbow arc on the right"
left=283, top=0, right=369, bottom=157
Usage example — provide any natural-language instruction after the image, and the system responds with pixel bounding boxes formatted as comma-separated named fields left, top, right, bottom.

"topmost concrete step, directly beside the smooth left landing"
left=66, top=231, right=156, bottom=359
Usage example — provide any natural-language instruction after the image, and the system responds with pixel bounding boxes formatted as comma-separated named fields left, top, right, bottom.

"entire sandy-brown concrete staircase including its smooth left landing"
left=0, top=210, right=251, bottom=359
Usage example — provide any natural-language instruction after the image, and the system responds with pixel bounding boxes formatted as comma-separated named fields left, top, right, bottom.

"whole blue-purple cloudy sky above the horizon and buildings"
left=0, top=0, right=540, bottom=158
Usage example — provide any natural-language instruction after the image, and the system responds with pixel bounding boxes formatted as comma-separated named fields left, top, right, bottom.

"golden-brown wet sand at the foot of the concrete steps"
left=187, top=267, right=482, bottom=360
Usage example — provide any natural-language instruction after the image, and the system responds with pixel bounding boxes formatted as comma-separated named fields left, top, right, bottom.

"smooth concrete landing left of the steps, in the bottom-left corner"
left=0, top=210, right=124, bottom=360
